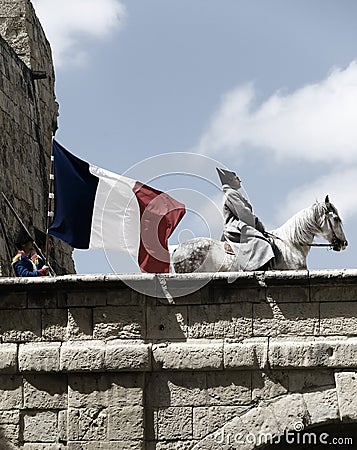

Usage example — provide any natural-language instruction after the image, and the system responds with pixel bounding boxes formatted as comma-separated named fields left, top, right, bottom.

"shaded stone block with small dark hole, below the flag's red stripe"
left=147, top=305, right=188, bottom=341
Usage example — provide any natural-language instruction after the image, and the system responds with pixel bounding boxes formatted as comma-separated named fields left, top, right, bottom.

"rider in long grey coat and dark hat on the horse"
left=217, top=168, right=274, bottom=271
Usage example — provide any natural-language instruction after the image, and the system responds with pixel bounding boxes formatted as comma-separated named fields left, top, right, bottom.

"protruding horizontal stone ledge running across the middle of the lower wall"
left=11, top=336, right=357, bottom=374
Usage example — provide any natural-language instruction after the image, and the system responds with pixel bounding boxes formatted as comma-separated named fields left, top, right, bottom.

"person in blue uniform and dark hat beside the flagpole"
left=12, top=229, right=48, bottom=277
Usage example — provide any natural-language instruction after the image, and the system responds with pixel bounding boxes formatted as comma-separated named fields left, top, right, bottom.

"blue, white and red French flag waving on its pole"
left=48, top=140, right=186, bottom=273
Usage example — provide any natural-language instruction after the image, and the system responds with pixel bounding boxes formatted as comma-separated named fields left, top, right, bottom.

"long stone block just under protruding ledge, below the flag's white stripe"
left=68, top=373, right=144, bottom=410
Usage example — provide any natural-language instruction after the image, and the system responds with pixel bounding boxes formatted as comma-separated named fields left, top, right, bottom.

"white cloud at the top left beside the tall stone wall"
left=33, top=0, right=126, bottom=68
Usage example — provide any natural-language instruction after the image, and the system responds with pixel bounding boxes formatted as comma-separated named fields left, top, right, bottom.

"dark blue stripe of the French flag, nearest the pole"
left=49, top=140, right=99, bottom=249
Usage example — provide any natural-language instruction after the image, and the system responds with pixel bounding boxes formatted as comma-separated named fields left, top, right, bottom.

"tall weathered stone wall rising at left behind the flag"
left=0, top=0, right=74, bottom=275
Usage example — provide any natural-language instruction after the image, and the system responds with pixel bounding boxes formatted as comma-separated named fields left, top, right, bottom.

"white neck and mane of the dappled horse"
left=272, top=202, right=326, bottom=245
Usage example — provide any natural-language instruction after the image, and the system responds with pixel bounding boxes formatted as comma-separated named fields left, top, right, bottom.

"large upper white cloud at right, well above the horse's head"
left=197, top=62, right=357, bottom=164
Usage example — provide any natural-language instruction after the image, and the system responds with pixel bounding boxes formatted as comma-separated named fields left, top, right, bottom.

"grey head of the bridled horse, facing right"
left=320, top=195, right=348, bottom=252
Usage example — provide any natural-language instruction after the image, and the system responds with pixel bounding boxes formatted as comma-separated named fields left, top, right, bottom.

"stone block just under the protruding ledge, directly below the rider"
left=207, top=370, right=252, bottom=406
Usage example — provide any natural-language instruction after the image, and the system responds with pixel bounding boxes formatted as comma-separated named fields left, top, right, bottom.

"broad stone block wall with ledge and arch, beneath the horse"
left=0, top=271, right=357, bottom=450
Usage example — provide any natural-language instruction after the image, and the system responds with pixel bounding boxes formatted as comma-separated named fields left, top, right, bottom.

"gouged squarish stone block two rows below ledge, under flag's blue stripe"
left=68, top=408, right=108, bottom=441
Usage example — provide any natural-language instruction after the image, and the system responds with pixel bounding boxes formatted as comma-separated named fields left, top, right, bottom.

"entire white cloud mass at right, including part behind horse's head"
left=196, top=61, right=357, bottom=227
